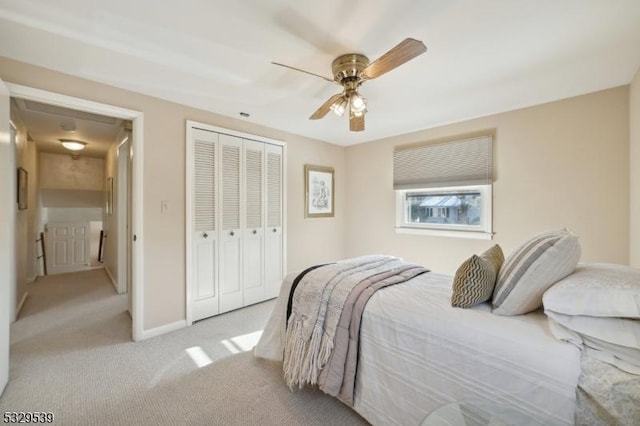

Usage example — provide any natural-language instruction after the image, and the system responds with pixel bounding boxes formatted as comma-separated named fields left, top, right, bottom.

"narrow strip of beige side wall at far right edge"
left=629, top=69, right=640, bottom=268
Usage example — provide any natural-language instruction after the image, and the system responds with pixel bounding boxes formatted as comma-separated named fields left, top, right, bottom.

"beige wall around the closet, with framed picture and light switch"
left=0, top=58, right=346, bottom=330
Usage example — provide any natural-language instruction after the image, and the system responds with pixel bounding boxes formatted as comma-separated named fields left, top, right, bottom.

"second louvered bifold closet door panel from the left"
left=218, top=134, right=243, bottom=313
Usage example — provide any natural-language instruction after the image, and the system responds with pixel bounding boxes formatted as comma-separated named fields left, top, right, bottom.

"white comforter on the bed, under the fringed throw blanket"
left=255, top=272, right=580, bottom=425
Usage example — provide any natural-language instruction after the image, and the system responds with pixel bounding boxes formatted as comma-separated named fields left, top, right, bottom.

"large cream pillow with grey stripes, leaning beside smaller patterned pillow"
left=493, top=229, right=580, bottom=315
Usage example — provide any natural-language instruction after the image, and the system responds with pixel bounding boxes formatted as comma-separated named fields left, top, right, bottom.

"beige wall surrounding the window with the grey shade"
left=346, top=86, right=629, bottom=274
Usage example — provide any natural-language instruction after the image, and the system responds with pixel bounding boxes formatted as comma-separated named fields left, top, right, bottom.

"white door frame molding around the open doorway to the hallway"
left=5, top=82, right=146, bottom=341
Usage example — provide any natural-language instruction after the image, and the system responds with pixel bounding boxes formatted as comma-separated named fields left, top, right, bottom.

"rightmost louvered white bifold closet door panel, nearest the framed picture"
left=264, top=144, right=284, bottom=299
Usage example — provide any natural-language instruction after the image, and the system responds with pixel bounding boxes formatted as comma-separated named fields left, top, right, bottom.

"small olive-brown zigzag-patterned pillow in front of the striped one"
left=451, top=244, right=504, bottom=308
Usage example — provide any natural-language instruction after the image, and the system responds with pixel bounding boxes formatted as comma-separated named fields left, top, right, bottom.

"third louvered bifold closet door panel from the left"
left=242, top=139, right=265, bottom=306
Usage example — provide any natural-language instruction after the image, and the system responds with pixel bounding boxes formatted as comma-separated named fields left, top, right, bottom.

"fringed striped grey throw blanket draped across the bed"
left=283, top=255, right=428, bottom=399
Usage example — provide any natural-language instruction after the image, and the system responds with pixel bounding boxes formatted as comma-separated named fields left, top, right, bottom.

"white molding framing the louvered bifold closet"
left=185, top=120, right=288, bottom=326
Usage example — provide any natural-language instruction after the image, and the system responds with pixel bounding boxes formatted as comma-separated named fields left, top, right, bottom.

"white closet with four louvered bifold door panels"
left=186, top=122, right=285, bottom=323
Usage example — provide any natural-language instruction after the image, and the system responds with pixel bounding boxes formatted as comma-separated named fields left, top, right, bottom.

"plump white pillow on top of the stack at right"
left=542, top=263, right=640, bottom=318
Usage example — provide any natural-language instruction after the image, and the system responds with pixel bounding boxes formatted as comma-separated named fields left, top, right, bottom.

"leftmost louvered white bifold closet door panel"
left=189, top=129, right=219, bottom=321
